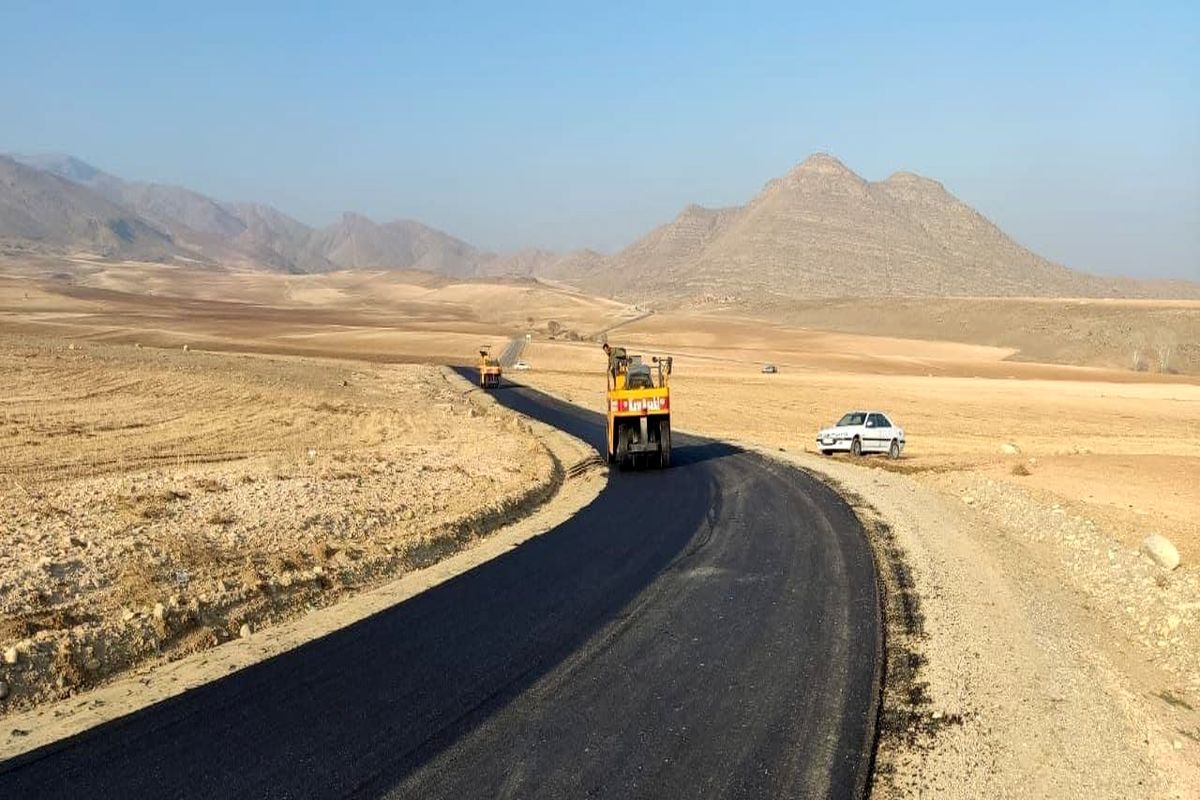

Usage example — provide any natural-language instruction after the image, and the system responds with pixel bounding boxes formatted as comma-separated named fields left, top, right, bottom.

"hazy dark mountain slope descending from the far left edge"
left=0, top=156, right=179, bottom=259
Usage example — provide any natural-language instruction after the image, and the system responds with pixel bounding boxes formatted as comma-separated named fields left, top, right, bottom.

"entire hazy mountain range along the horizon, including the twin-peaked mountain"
left=0, top=154, right=1200, bottom=299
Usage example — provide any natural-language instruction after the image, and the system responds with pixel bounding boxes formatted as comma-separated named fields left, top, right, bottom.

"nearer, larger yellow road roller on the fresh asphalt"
left=604, top=343, right=671, bottom=469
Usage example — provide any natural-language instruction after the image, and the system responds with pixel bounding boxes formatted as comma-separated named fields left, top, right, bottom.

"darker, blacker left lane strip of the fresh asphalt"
left=0, top=368, right=720, bottom=799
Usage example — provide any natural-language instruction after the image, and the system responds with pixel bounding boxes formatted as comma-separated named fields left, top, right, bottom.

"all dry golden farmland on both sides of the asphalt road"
left=0, top=257, right=1200, bottom=724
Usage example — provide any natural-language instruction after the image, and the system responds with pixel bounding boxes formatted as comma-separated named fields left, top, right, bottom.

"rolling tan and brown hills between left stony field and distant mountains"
left=0, top=257, right=643, bottom=363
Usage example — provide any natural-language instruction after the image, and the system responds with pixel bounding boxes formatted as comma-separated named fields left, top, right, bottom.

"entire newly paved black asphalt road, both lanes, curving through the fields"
left=0, top=373, right=881, bottom=800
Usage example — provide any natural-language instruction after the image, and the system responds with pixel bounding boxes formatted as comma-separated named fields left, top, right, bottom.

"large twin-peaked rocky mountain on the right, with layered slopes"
left=564, top=154, right=1130, bottom=305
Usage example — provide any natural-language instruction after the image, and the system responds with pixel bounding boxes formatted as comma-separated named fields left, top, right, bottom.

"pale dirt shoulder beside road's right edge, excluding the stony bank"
left=751, top=447, right=1200, bottom=800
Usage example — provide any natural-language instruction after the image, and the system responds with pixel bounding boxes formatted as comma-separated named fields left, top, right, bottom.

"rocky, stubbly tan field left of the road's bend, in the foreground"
left=0, top=337, right=560, bottom=714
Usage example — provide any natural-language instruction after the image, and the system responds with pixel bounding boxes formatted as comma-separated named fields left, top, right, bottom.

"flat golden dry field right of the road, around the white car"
left=522, top=309, right=1200, bottom=569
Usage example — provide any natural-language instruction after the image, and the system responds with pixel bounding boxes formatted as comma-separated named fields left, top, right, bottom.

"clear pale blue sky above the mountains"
left=0, top=0, right=1200, bottom=279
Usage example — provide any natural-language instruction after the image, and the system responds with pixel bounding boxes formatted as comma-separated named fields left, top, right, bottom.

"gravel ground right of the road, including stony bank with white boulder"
left=744, top=443, right=1200, bottom=800
